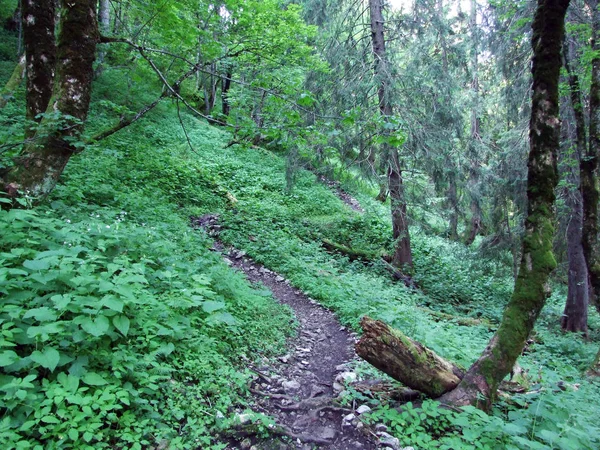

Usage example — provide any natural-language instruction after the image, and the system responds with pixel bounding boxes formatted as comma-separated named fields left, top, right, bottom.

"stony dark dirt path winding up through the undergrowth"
left=216, top=244, right=377, bottom=450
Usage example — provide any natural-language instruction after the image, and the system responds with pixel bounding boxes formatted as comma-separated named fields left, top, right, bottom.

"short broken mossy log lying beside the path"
left=356, top=317, right=464, bottom=398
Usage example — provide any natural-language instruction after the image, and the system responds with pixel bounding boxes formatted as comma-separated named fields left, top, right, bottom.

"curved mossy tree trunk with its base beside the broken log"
left=442, top=0, right=569, bottom=409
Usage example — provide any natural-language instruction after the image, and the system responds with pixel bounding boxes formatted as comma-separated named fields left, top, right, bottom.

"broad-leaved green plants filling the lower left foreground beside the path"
left=0, top=202, right=270, bottom=449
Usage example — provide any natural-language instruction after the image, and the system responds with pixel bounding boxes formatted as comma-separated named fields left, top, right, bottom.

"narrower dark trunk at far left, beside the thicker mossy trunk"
left=22, top=0, right=56, bottom=138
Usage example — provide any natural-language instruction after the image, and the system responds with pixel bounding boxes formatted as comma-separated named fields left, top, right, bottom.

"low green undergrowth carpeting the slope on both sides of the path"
left=0, top=64, right=600, bottom=449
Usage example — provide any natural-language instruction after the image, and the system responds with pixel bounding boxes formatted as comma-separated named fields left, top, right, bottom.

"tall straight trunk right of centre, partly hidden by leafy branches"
left=369, top=0, right=412, bottom=269
